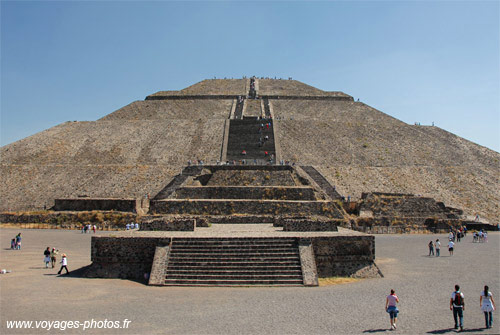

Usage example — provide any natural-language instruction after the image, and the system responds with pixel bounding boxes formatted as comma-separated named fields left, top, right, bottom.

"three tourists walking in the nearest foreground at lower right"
left=385, top=285, right=496, bottom=331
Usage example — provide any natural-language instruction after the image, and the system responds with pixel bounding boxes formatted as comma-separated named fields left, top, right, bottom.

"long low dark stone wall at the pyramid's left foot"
left=54, top=198, right=137, bottom=212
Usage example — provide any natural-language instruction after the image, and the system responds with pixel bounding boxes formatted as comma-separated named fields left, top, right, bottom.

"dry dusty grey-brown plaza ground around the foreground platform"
left=0, top=229, right=500, bottom=334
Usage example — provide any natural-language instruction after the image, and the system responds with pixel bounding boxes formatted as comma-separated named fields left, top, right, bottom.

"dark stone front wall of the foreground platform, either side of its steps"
left=84, top=235, right=382, bottom=281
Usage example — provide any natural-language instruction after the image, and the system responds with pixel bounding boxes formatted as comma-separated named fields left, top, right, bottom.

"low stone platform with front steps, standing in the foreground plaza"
left=86, top=223, right=381, bottom=286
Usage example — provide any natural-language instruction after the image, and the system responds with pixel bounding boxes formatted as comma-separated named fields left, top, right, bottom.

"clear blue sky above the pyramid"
left=0, top=1, right=500, bottom=152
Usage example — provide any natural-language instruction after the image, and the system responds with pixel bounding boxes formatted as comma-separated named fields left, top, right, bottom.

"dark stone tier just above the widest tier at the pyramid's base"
left=174, top=186, right=315, bottom=200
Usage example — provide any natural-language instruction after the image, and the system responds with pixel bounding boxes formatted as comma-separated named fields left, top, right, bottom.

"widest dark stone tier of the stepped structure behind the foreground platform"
left=150, top=199, right=344, bottom=220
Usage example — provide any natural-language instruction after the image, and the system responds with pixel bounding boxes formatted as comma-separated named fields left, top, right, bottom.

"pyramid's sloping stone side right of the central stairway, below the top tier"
left=272, top=100, right=500, bottom=222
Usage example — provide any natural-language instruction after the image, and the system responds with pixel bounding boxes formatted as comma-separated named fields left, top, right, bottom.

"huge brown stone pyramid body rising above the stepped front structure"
left=0, top=78, right=500, bottom=223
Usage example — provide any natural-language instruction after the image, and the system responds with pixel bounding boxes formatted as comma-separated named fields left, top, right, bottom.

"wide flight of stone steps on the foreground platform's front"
left=165, top=237, right=303, bottom=286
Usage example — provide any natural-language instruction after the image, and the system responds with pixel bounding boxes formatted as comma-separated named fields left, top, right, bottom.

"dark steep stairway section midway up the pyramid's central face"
left=226, top=118, right=276, bottom=164
